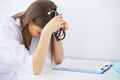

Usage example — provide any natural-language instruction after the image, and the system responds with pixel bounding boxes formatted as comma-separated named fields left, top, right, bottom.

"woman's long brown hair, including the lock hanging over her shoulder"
left=13, top=0, right=56, bottom=50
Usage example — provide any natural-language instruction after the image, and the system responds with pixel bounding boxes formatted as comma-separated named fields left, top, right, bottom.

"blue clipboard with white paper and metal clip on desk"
left=52, top=59, right=112, bottom=74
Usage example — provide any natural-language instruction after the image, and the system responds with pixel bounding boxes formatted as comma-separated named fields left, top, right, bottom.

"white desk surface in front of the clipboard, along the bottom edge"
left=20, top=69, right=120, bottom=80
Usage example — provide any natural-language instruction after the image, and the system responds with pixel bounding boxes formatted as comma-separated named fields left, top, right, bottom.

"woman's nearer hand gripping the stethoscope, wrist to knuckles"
left=43, top=15, right=65, bottom=33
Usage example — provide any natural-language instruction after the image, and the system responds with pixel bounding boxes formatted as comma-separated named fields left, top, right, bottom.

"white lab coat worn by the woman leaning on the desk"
left=0, top=17, right=50, bottom=80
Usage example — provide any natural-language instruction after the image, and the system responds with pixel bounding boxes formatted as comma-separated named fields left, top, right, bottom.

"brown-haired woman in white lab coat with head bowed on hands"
left=0, top=0, right=67, bottom=76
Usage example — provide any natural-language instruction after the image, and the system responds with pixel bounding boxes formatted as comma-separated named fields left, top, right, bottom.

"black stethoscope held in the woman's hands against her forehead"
left=48, top=7, right=66, bottom=41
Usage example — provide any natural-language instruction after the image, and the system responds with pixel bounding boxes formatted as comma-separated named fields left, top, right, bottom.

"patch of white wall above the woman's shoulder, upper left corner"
left=0, top=0, right=34, bottom=21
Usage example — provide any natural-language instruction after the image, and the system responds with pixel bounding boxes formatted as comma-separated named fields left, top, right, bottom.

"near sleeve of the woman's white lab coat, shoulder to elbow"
left=0, top=26, right=33, bottom=74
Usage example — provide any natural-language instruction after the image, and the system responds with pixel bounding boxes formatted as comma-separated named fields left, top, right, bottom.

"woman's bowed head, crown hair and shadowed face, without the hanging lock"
left=23, top=0, right=56, bottom=37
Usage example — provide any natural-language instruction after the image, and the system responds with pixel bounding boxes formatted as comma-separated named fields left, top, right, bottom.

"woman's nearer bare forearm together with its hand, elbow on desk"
left=33, top=15, right=64, bottom=74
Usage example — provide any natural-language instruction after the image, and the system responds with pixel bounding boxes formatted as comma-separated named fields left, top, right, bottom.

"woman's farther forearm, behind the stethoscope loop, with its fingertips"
left=51, top=22, right=68, bottom=64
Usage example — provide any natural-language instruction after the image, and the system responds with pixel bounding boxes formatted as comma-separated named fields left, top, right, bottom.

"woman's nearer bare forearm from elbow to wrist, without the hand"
left=33, top=31, right=51, bottom=75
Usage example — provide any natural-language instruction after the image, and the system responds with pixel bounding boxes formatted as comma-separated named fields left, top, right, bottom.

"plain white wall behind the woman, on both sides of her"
left=0, top=0, right=120, bottom=61
